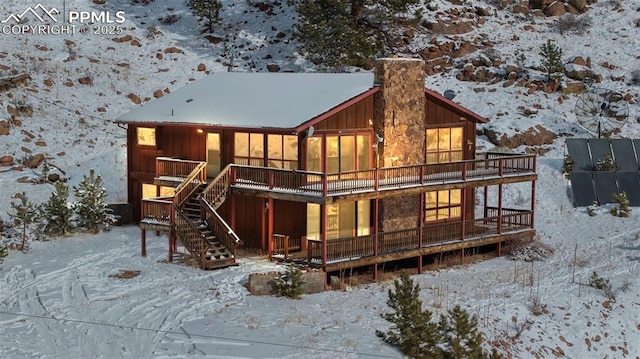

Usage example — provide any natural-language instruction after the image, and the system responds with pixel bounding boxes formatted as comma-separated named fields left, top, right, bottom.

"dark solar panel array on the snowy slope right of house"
left=566, top=138, right=640, bottom=207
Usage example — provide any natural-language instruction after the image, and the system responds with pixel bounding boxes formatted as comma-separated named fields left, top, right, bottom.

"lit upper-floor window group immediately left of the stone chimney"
left=307, top=134, right=371, bottom=173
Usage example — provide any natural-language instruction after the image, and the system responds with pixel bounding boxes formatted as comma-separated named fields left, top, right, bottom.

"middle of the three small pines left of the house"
left=40, top=181, right=73, bottom=236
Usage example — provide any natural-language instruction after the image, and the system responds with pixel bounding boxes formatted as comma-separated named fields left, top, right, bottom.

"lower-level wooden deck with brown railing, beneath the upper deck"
left=271, top=209, right=535, bottom=271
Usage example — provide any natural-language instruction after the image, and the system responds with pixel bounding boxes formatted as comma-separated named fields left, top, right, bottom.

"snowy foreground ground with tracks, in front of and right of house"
left=0, top=153, right=640, bottom=358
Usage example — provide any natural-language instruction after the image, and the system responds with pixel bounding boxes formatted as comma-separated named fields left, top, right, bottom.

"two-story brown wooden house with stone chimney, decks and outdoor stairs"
left=117, top=58, right=537, bottom=276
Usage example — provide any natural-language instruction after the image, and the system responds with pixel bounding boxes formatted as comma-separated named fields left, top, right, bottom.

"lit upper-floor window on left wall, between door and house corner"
left=234, top=132, right=298, bottom=169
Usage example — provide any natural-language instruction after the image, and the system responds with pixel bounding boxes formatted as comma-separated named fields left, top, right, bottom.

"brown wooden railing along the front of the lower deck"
left=307, top=210, right=532, bottom=264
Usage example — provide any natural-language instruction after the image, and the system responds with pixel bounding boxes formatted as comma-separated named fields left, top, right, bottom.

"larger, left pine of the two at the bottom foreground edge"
left=376, top=272, right=441, bottom=359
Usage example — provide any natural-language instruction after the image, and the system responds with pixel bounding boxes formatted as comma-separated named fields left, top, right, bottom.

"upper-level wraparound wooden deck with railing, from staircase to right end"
left=230, top=155, right=537, bottom=204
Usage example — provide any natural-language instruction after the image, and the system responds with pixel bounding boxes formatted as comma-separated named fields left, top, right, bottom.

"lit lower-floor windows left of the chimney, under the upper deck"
left=307, top=200, right=371, bottom=239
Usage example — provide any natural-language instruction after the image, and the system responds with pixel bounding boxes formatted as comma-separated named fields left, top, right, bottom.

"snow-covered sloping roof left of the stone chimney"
left=116, top=72, right=374, bottom=129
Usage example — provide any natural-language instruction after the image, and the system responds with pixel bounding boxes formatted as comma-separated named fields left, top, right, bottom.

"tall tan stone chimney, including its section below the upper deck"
left=373, top=58, right=426, bottom=232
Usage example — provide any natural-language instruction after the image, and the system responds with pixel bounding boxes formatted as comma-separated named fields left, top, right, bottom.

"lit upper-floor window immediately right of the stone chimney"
left=427, top=127, right=463, bottom=163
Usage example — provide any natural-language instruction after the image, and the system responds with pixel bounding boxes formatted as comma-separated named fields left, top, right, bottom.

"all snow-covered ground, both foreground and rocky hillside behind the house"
left=0, top=0, right=640, bottom=358
